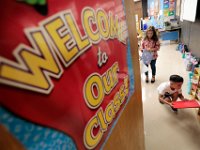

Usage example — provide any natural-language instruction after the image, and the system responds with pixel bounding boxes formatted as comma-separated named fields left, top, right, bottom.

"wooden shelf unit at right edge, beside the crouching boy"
left=190, top=68, right=200, bottom=115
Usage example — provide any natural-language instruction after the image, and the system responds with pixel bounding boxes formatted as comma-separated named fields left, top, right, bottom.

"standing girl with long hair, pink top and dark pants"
left=141, top=26, right=160, bottom=83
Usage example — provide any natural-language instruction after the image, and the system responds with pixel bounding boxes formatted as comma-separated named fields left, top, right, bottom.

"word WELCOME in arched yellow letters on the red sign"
left=0, top=7, right=125, bottom=94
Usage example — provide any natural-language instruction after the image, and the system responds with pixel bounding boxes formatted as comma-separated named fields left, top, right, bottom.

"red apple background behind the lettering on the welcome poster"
left=0, top=0, right=128, bottom=149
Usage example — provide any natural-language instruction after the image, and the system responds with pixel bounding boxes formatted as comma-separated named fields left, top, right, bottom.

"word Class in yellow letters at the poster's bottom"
left=84, top=74, right=128, bottom=149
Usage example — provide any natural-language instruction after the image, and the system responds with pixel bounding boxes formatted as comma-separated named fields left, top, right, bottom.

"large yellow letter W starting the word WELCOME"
left=0, top=31, right=62, bottom=94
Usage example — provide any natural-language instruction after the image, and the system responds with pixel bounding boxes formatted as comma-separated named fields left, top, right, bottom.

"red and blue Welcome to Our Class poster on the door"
left=0, top=0, right=134, bottom=150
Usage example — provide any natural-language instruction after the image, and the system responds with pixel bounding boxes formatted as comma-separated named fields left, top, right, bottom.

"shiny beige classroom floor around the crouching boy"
left=142, top=44, right=200, bottom=150
